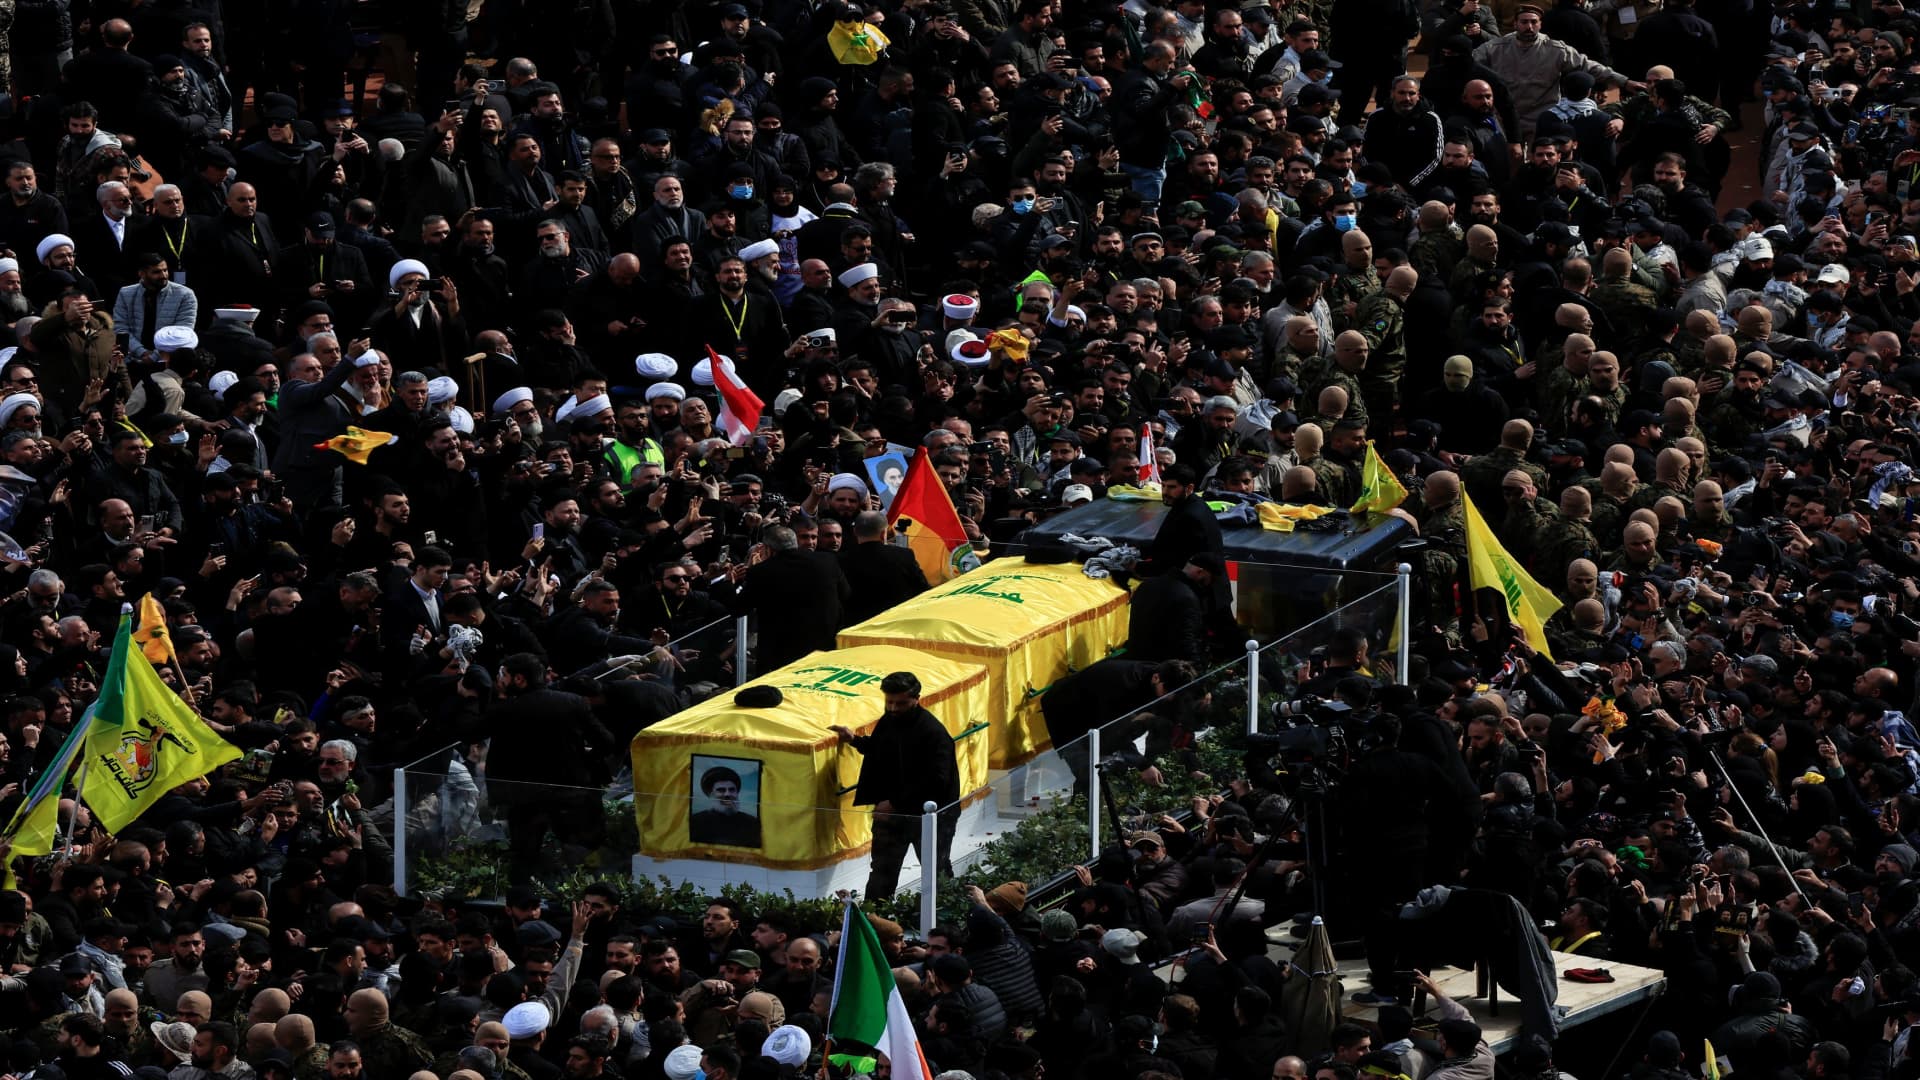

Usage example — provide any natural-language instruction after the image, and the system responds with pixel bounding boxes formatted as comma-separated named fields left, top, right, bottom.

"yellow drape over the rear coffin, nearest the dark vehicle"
left=839, top=559, right=1127, bottom=769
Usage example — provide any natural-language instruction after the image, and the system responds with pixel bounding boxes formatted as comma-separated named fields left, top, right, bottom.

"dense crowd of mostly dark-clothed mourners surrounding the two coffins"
left=0, top=0, right=1920, bottom=1080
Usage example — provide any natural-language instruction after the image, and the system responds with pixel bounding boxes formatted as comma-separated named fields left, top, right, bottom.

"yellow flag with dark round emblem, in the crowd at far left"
left=81, top=615, right=240, bottom=832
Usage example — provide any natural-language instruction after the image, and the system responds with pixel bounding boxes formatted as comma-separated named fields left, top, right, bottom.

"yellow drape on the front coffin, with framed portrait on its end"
left=634, top=646, right=989, bottom=869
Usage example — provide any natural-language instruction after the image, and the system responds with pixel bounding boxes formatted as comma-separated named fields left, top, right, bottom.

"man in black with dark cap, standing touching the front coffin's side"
left=833, top=671, right=960, bottom=899
